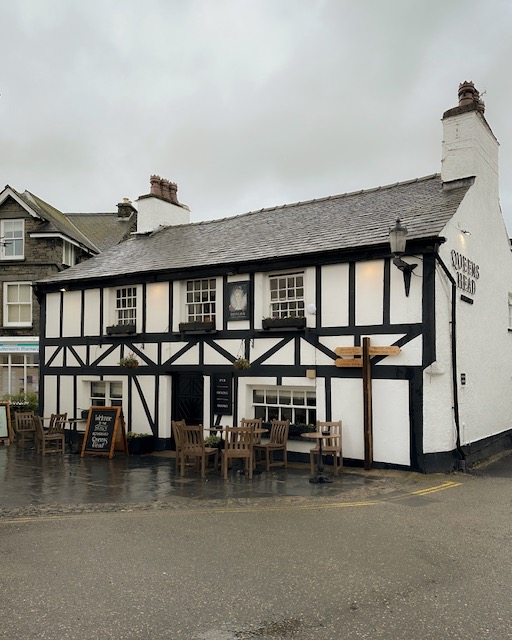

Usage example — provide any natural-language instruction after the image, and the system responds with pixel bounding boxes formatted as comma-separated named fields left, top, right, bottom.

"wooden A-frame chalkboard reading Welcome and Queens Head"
left=82, top=407, right=128, bottom=458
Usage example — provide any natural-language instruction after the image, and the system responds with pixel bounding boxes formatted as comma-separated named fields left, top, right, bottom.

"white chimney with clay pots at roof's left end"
left=137, top=176, right=190, bottom=233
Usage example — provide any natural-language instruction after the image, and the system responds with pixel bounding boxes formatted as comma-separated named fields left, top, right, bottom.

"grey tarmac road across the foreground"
left=0, top=456, right=512, bottom=640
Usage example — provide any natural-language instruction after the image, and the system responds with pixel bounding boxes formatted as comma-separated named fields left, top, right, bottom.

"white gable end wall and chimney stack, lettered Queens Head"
left=424, top=104, right=512, bottom=452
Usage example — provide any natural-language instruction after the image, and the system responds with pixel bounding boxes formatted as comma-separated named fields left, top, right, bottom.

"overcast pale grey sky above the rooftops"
left=0, top=0, right=512, bottom=234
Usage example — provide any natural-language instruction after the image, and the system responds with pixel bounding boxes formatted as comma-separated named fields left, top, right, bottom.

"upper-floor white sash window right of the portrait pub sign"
left=268, top=271, right=306, bottom=318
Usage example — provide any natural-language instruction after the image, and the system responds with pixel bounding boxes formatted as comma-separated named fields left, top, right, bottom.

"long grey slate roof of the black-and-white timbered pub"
left=37, top=174, right=470, bottom=283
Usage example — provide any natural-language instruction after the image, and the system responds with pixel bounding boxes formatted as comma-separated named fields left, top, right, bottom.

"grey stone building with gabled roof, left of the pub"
left=0, top=185, right=136, bottom=397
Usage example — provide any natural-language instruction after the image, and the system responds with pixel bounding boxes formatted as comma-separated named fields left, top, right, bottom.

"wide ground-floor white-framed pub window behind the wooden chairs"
left=252, top=386, right=318, bottom=424
